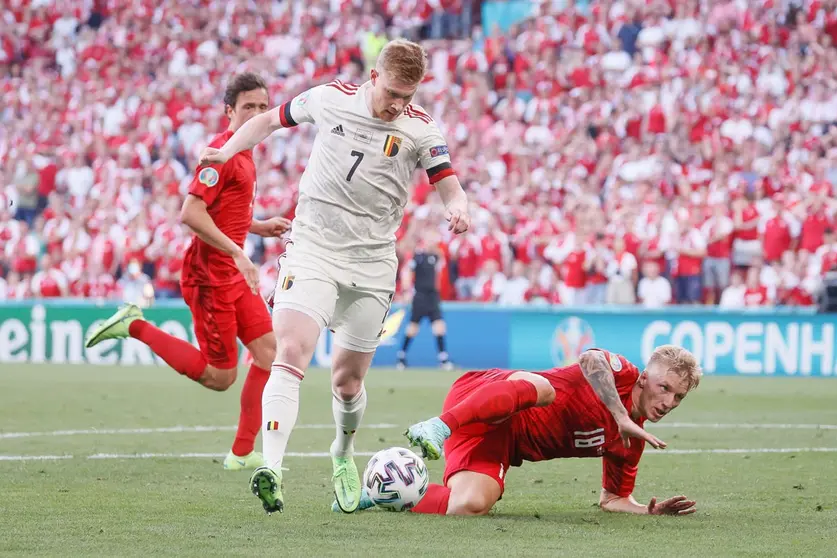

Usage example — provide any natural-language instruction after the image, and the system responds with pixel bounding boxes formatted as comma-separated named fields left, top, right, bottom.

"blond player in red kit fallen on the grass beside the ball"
left=340, top=345, right=701, bottom=515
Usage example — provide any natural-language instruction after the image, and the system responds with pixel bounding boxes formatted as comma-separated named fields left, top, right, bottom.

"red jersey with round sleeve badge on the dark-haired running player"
left=181, top=131, right=256, bottom=287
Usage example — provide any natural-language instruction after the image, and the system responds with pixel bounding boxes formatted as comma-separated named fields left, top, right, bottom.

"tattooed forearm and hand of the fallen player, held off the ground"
left=578, top=349, right=666, bottom=449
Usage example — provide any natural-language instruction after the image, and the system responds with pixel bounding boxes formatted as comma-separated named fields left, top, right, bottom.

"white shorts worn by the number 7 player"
left=273, top=244, right=398, bottom=353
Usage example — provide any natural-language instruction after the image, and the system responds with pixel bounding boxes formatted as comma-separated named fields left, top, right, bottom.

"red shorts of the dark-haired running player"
left=181, top=281, right=273, bottom=370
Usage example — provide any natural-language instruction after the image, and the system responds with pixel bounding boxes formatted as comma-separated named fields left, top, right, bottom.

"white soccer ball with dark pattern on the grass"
left=363, top=448, right=430, bottom=511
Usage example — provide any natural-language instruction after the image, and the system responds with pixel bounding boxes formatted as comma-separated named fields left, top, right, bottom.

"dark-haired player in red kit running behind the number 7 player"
left=87, top=73, right=290, bottom=470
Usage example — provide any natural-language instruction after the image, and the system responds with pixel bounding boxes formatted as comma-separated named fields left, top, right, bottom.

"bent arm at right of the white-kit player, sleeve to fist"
left=419, top=122, right=471, bottom=234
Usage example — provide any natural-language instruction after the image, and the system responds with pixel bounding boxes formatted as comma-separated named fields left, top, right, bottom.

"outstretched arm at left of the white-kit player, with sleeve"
left=198, top=85, right=325, bottom=166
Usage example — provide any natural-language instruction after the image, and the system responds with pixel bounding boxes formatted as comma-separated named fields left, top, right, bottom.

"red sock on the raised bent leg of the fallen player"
left=439, top=380, right=538, bottom=432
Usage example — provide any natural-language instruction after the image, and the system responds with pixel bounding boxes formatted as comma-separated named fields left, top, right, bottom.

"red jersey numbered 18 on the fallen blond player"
left=511, top=351, right=645, bottom=497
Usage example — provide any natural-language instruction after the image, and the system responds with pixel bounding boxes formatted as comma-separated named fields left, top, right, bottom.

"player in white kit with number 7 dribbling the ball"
left=200, top=39, right=470, bottom=513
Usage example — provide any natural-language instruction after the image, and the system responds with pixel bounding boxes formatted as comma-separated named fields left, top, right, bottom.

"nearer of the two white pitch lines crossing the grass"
left=0, top=448, right=837, bottom=461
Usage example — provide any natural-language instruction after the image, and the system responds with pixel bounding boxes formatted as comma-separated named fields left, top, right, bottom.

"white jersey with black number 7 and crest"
left=279, top=80, right=453, bottom=261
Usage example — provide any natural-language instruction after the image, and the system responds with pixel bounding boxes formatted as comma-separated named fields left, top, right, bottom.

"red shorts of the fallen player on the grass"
left=442, top=370, right=514, bottom=493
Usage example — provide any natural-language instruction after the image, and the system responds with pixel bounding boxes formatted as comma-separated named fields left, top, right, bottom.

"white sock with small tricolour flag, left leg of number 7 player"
left=262, top=362, right=305, bottom=473
